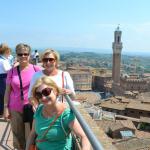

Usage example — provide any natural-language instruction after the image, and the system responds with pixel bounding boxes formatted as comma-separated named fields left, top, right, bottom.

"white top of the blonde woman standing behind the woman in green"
left=28, top=70, right=75, bottom=101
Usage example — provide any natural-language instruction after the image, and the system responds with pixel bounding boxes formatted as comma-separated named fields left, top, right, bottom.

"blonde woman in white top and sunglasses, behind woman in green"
left=28, top=49, right=75, bottom=109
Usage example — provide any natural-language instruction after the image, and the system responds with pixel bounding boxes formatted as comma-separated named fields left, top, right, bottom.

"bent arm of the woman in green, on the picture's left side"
left=25, top=120, right=36, bottom=150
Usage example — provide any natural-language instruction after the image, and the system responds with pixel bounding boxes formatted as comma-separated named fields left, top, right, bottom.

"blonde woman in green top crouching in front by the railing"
left=26, top=76, right=90, bottom=150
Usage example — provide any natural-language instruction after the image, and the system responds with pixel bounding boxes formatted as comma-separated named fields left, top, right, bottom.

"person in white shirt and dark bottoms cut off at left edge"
left=0, top=43, right=11, bottom=117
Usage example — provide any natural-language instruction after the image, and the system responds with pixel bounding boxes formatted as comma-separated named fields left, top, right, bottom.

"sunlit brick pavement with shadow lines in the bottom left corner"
left=0, top=118, right=13, bottom=150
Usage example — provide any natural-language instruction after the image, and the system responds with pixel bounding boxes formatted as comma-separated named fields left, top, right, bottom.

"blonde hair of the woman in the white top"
left=41, top=48, right=60, bottom=67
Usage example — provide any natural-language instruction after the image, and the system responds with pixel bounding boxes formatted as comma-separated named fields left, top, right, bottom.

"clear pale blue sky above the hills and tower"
left=0, top=0, right=150, bottom=52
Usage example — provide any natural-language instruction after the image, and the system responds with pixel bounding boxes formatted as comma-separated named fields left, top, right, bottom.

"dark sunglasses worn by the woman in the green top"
left=35, top=87, right=52, bottom=99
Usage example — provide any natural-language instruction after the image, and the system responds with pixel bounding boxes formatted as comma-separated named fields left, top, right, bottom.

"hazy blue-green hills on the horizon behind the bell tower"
left=60, top=52, right=150, bottom=72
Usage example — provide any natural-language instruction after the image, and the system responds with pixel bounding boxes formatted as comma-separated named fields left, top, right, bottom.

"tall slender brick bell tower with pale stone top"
left=112, top=26, right=122, bottom=86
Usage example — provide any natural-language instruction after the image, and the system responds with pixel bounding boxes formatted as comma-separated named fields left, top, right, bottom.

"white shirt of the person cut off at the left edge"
left=0, top=55, right=11, bottom=74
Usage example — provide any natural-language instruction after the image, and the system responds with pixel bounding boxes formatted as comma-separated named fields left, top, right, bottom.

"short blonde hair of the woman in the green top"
left=32, top=76, right=62, bottom=98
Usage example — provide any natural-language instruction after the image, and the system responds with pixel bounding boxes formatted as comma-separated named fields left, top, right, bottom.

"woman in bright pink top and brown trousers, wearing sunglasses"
left=4, top=43, right=40, bottom=150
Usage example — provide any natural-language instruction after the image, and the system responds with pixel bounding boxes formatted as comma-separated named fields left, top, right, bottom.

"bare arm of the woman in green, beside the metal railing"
left=69, top=119, right=91, bottom=150
